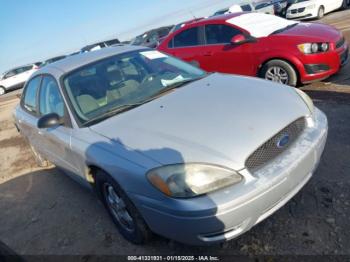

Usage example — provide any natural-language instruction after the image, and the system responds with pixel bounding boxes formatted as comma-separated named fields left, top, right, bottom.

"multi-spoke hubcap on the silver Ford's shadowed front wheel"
left=103, top=183, right=135, bottom=232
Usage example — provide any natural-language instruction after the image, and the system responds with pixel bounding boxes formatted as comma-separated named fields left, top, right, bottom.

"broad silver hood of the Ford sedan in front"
left=90, top=74, right=309, bottom=170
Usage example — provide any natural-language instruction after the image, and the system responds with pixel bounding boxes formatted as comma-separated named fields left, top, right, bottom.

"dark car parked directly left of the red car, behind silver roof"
left=130, top=26, right=173, bottom=48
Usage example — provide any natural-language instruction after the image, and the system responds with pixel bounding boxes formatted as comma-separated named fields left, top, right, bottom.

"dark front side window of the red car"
left=205, top=24, right=241, bottom=45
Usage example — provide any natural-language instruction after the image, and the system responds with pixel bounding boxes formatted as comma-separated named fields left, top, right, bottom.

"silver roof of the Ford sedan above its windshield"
left=32, top=44, right=145, bottom=77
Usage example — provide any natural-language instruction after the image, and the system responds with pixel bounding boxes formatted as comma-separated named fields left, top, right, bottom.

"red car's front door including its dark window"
left=202, top=24, right=254, bottom=75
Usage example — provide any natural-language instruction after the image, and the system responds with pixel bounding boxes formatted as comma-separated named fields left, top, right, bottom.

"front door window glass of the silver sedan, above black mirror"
left=39, top=76, right=64, bottom=117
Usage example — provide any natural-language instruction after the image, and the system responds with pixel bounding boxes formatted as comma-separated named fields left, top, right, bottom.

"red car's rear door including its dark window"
left=163, top=26, right=205, bottom=69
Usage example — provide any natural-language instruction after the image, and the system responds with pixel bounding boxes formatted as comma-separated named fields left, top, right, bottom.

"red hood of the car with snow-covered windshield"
left=277, top=23, right=341, bottom=42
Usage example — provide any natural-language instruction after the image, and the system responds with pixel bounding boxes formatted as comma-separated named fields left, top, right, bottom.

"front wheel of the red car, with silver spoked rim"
left=259, top=59, right=298, bottom=87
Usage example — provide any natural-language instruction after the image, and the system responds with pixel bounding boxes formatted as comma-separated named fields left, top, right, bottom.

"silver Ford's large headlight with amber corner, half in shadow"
left=147, top=163, right=243, bottom=198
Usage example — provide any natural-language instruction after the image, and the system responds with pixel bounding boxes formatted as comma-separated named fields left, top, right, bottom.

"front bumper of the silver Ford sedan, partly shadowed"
left=131, top=109, right=328, bottom=245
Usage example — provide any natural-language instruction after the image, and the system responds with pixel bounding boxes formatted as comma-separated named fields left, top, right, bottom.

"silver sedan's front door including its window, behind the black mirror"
left=38, top=75, right=79, bottom=174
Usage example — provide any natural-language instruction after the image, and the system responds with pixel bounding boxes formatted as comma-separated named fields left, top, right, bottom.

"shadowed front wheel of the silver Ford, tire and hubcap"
left=95, top=170, right=152, bottom=244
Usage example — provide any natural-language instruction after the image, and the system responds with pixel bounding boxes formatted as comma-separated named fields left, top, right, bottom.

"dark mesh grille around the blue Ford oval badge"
left=245, top=117, right=306, bottom=172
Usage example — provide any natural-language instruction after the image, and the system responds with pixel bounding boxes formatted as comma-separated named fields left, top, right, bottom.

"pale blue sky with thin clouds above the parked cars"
left=0, top=0, right=241, bottom=74
